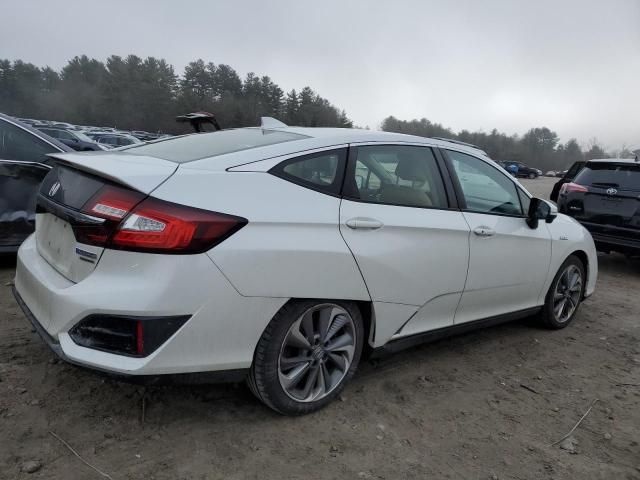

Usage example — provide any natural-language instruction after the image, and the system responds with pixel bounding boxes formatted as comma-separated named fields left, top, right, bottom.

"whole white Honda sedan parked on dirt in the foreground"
left=15, top=119, right=597, bottom=414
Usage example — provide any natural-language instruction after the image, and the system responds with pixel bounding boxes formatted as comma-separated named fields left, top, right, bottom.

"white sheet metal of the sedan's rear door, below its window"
left=340, top=200, right=469, bottom=344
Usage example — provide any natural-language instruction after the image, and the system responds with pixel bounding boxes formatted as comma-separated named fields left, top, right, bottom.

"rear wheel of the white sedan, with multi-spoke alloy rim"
left=248, top=300, right=364, bottom=415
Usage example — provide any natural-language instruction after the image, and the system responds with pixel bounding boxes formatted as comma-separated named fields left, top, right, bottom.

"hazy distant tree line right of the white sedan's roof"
left=382, top=116, right=632, bottom=172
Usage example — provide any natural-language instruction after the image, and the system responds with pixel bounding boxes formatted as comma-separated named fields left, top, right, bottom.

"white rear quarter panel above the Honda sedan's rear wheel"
left=153, top=168, right=370, bottom=300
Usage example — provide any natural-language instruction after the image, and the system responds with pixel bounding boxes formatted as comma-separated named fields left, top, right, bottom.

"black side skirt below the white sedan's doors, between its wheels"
left=370, top=306, right=542, bottom=358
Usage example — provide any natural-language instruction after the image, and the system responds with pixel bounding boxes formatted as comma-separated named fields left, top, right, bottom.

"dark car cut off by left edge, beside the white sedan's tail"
left=0, top=118, right=60, bottom=252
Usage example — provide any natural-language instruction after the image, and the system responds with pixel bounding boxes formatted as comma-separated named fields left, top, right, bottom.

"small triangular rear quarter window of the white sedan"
left=269, top=148, right=347, bottom=195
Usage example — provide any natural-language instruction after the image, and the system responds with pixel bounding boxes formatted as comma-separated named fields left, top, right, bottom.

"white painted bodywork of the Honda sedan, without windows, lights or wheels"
left=15, top=128, right=597, bottom=375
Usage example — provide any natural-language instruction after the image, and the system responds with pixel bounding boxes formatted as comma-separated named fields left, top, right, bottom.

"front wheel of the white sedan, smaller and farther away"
left=542, top=255, right=586, bottom=329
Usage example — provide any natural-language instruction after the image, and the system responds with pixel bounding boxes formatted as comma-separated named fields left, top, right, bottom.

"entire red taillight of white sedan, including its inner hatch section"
left=73, top=185, right=247, bottom=254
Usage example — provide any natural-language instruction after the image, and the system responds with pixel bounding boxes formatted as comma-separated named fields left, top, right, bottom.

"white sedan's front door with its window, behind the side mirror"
left=444, top=150, right=551, bottom=323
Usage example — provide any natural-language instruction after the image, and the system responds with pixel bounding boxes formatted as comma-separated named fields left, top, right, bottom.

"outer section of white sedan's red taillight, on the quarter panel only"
left=109, top=198, right=247, bottom=253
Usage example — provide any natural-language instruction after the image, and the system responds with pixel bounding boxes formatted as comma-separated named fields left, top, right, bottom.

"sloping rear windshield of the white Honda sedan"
left=121, top=128, right=309, bottom=163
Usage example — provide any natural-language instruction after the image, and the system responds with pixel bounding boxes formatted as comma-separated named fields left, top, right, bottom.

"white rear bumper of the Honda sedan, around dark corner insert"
left=15, top=236, right=287, bottom=381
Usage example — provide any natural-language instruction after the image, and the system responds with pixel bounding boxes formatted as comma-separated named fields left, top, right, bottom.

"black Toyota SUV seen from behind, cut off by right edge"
left=558, top=159, right=640, bottom=254
